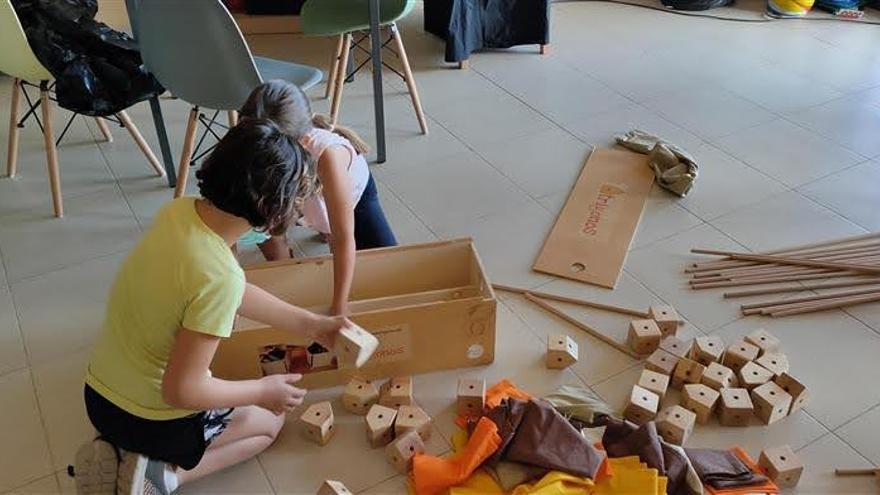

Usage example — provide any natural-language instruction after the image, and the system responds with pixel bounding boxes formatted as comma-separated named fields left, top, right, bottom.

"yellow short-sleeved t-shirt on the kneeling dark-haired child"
left=86, top=198, right=245, bottom=420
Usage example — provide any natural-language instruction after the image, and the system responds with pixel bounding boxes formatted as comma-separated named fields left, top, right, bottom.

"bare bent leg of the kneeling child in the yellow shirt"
left=177, top=406, right=284, bottom=485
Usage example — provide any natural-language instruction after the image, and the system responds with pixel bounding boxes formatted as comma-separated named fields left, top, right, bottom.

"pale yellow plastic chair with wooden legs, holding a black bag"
left=0, top=0, right=165, bottom=218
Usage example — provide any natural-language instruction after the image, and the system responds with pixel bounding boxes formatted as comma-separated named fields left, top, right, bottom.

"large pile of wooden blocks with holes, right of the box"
left=624, top=330, right=808, bottom=445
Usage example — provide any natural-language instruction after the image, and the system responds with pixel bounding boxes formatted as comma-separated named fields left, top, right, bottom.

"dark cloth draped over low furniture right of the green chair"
left=425, top=0, right=550, bottom=62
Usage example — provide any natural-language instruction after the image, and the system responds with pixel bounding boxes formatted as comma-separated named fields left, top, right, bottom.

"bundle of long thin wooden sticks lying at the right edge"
left=685, top=232, right=880, bottom=317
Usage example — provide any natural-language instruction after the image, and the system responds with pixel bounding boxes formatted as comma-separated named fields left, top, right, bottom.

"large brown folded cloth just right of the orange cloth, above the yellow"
left=504, top=400, right=603, bottom=478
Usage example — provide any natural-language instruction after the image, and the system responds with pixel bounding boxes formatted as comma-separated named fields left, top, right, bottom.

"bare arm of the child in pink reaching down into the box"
left=318, top=146, right=355, bottom=315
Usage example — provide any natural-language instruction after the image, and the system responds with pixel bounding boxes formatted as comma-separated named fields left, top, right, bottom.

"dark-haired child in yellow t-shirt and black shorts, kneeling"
left=75, top=119, right=350, bottom=494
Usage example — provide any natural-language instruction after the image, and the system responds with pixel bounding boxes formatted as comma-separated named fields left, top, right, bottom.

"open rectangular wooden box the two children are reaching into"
left=211, top=239, right=496, bottom=388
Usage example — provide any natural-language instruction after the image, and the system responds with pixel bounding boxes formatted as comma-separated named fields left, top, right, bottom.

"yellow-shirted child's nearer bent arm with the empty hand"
left=162, top=328, right=306, bottom=414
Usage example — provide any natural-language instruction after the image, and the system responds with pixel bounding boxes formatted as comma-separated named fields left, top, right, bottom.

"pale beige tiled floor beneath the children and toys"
left=0, top=2, right=880, bottom=494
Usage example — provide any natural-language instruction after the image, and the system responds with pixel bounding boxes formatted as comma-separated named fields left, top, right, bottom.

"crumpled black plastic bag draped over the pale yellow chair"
left=12, top=0, right=165, bottom=116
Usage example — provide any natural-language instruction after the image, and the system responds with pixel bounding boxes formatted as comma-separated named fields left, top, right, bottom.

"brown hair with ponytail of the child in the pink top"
left=240, top=79, right=370, bottom=158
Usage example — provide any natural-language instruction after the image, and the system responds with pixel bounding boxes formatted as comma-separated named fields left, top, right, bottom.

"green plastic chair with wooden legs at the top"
left=300, top=0, right=428, bottom=134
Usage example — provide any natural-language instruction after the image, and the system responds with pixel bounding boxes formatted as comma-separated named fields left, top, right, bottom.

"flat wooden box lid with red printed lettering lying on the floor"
left=532, top=148, right=654, bottom=289
